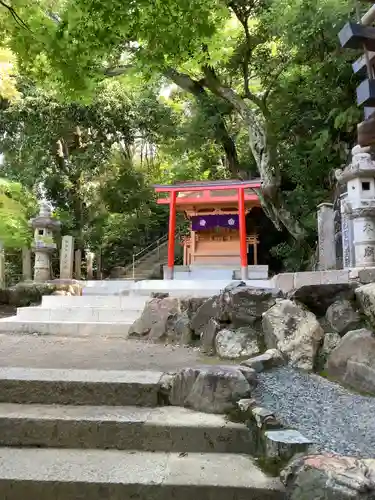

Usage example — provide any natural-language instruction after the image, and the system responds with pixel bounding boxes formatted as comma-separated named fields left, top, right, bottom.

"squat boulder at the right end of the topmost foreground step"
left=168, top=366, right=256, bottom=413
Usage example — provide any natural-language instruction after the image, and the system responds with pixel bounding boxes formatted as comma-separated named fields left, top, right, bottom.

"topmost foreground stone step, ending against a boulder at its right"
left=0, top=368, right=162, bottom=407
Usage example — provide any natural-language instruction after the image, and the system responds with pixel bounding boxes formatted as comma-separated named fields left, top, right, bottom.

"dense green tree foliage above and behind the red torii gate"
left=0, top=0, right=360, bottom=270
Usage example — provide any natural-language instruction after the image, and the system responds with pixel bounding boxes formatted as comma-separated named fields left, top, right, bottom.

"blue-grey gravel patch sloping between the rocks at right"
left=254, top=367, right=375, bottom=458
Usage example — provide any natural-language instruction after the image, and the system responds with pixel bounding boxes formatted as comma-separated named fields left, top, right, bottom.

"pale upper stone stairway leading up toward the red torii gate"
left=0, top=280, right=270, bottom=338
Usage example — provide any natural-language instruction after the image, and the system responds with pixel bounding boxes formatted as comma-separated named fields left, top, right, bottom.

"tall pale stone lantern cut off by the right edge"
left=339, top=146, right=375, bottom=267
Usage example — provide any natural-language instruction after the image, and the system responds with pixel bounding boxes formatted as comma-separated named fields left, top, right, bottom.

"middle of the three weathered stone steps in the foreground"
left=0, top=403, right=252, bottom=453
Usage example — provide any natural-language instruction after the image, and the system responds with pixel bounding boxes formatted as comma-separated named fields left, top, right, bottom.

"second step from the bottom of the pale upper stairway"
left=17, top=306, right=142, bottom=323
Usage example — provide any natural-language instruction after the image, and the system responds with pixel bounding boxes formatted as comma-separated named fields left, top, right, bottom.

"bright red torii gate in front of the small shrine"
left=154, top=179, right=261, bottom=280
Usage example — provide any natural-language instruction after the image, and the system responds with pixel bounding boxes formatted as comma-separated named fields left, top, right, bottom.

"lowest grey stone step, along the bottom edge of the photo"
left=0, top=448, right=286, bottom=500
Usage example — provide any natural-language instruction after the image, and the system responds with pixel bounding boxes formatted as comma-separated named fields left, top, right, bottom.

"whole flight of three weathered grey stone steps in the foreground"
left=0, top=368, right=285, bottom=500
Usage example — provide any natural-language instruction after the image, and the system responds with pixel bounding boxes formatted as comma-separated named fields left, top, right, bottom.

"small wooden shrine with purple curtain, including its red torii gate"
left=154, top=180, right=268, bottom=280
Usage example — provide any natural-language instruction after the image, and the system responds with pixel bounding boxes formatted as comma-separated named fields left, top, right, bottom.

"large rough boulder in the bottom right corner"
left=281, top=454, right=375, bottom=500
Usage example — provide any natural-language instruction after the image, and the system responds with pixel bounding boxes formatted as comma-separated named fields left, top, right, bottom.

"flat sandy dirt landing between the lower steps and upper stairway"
left=0, top=334, right=218, bottom=371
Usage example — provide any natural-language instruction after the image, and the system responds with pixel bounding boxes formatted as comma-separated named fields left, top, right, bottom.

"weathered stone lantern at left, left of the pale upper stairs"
left=30, top=201, right=61, bottom=281
